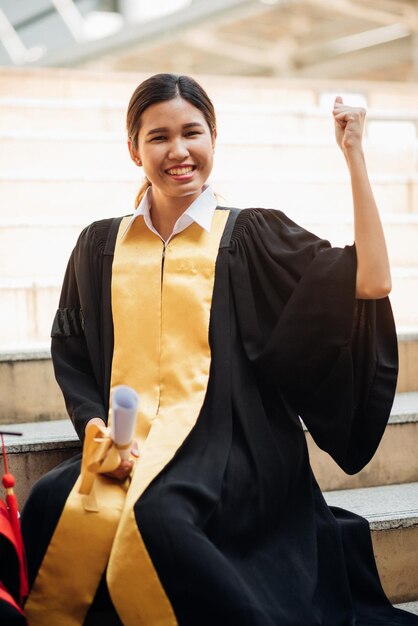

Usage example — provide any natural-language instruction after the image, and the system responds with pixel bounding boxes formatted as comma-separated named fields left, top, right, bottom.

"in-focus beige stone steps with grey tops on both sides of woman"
left=0, top=342, right=418, bottom=614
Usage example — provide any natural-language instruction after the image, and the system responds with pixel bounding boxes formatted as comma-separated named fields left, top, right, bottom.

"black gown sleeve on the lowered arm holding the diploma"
left=51, top=224, right=107, bottom=440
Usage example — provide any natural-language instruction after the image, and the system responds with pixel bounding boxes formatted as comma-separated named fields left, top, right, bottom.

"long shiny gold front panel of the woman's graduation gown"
left=26, top=211, right=229, bottom=626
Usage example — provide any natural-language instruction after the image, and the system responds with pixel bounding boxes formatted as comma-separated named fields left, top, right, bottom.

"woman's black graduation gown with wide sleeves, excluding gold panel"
left=22, top=209, right=418, bottom=626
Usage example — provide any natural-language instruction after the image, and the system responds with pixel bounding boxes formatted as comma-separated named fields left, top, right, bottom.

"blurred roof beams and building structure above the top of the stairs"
left=0, top=0, right=418, bottom=81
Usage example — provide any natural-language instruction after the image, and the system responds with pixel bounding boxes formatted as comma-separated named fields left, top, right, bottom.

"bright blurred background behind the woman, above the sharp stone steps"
left=0, top=0, right=418, bottom=346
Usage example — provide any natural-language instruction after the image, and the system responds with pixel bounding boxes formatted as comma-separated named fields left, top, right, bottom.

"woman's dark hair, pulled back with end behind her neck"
left=126, top=74, right=216, bottom=208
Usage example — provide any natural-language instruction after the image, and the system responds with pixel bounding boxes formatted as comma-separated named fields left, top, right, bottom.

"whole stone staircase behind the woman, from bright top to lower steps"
left=0, top=69, right=418, bottom=610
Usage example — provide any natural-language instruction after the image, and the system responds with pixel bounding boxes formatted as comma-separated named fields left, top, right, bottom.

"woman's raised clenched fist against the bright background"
left=332, top=96, right=366, bottom=156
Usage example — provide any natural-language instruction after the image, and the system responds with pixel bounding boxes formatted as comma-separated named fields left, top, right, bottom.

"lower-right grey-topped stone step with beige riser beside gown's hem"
left=324, top=483, right=418, bottom=602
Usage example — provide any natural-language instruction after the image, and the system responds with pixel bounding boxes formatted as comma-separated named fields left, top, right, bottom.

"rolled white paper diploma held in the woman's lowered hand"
left=110, top=385, right=139, bottom=460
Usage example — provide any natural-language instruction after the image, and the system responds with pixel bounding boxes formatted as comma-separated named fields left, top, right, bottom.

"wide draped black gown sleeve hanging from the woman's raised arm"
left=230, top=209, right=398, bottom=474
